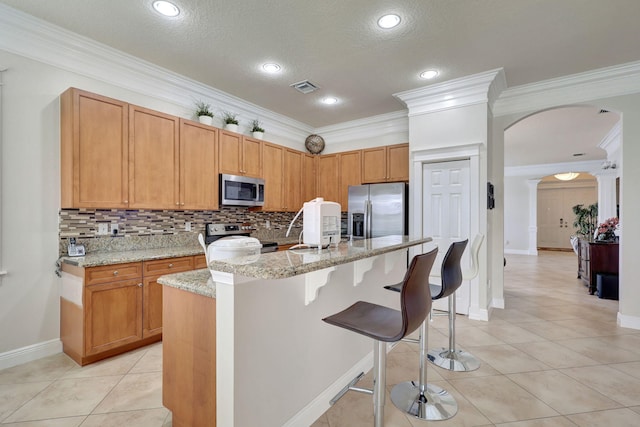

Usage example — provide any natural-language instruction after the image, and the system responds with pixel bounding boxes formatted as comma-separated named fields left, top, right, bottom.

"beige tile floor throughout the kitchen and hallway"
left=0, top=252, right=640, bottom=427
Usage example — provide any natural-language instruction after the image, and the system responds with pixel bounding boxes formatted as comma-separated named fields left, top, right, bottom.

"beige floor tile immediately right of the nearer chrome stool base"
left=449, top=376, right=560, bottom=423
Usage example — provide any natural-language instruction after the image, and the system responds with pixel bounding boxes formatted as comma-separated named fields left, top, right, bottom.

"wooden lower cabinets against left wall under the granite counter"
left=60, top=255, right=200, bottom=365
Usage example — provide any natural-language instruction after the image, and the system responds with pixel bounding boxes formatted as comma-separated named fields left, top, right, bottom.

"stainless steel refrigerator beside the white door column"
left=347, top=182, right=409, bottom=239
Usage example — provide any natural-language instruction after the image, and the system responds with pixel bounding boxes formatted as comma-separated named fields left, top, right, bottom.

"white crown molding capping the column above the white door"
left=393, top=68, right=506, bottom=116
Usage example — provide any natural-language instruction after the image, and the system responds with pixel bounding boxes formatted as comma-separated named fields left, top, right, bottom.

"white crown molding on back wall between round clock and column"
left=314, top=110, right=409, bottom=144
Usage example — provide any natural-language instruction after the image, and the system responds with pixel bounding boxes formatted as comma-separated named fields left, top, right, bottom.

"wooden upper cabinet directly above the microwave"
left=218, top=130, right=262, bottom=177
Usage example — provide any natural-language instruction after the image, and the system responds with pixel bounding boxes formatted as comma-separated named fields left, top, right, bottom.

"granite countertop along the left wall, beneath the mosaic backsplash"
left=60, top=246, right=204, bottom=267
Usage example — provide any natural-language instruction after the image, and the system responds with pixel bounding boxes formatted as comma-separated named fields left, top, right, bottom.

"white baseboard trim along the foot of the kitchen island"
left=283, top=346, right=376, bottom=427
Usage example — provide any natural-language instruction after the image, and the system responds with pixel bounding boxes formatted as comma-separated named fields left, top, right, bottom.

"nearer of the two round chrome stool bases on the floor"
left=391, top=381, right=458, bottom=421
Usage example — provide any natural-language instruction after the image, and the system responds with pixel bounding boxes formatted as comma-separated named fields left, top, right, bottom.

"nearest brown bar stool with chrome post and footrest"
left=322, top=249, right=438, bottom=427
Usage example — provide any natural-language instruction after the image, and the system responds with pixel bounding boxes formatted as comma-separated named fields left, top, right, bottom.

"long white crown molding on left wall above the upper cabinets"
left=0, top=4, right=314, bottom=144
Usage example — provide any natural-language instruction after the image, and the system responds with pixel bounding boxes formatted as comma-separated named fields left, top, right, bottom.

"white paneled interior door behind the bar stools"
left=422, top=160, right=471, bottom=314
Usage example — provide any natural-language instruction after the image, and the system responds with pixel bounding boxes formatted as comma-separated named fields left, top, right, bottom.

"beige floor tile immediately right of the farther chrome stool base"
left=472, top=344, right=551, bottom=374
